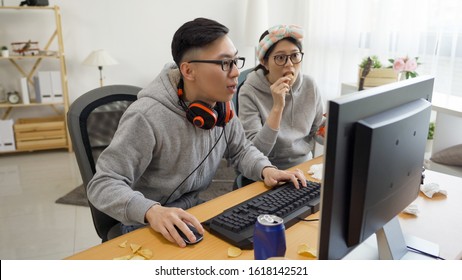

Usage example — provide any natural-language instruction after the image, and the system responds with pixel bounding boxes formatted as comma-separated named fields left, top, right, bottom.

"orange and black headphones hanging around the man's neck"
left=177, top=79, right=234, bottom=129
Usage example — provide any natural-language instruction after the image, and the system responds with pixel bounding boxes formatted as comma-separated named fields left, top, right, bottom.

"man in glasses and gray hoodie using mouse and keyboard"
left=88, top=18, right=306, bottom=247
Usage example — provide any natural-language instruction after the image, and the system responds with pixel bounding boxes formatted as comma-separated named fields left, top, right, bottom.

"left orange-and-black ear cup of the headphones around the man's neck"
left=186, top=101, right=218, bottom=129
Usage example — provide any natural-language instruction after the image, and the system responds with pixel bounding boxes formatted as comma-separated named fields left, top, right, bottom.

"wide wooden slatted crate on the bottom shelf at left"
left=14, top=116, right=67, bottom=151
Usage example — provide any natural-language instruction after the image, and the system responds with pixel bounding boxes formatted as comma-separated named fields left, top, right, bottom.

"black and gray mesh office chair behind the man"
left=67, top=85, right=141, bottom=242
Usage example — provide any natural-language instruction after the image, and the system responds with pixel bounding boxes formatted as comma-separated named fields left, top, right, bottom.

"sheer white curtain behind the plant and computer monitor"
left=298, top=0, right=462, bottom=100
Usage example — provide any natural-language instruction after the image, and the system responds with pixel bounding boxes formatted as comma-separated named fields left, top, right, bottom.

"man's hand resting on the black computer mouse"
left=145, top=204, right=204, bottom=248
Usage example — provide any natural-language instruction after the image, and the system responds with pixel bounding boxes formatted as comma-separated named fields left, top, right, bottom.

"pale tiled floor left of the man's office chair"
left=0, top=150, right=101, bottom=260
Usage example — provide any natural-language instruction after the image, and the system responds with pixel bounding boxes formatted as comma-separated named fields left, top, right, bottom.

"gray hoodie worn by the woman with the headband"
left=239, top=69, right=323, bottom=169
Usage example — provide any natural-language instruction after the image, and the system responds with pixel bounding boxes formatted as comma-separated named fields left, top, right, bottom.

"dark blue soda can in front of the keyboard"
left=253, top=214, right=286, bottom=260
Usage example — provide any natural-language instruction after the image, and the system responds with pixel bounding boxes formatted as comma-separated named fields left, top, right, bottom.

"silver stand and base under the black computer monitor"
left=343, top=217, right=440, bottom=260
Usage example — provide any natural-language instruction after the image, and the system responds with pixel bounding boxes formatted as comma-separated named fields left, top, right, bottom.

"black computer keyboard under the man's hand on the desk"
left=202, top=181, right=321, bottom=249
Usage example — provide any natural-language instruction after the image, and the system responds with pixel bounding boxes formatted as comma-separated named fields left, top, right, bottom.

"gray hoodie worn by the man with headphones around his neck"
left=88, top=63, right=271, bottom=225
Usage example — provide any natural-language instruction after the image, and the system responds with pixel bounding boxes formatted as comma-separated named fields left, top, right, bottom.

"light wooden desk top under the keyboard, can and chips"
left=68, top=157, right=462, bottom=260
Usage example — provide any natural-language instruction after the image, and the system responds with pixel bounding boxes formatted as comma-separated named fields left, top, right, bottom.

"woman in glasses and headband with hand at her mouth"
left=238, top=25, right=323, bottom=173
